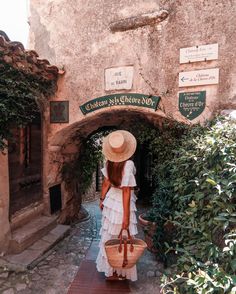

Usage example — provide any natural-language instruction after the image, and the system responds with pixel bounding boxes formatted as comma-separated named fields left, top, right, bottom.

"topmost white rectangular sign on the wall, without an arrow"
left=179, top=44, right=219, bottom=63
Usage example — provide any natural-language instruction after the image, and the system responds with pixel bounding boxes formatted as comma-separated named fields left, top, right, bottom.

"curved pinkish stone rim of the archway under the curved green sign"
left=44, top=108, right=169, bottom=222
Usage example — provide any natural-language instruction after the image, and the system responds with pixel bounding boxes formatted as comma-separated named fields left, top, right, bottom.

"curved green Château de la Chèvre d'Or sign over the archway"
left=80, top=93, right=160, bottom=114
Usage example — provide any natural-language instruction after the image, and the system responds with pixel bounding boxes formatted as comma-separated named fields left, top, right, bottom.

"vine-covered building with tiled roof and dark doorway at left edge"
left=0, top=31, right=65, bottom=253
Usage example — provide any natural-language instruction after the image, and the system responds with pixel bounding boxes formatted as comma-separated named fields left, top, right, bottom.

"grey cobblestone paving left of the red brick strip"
left=0, top=202, right=99, bottom=294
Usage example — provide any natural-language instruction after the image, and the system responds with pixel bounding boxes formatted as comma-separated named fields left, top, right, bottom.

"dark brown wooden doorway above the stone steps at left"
left=8, top=113, right=42, bottom=219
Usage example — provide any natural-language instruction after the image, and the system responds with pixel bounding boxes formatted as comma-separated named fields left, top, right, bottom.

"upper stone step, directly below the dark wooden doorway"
left=9, top=215, right=57, bottom=254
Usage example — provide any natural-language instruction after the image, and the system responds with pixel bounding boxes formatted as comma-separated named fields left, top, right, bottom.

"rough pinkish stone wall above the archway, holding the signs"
left=29, top=0, right=236, bottom=216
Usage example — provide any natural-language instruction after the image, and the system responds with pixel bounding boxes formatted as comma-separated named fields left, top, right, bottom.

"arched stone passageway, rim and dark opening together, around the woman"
left=48, top=108, right=174, bottom=222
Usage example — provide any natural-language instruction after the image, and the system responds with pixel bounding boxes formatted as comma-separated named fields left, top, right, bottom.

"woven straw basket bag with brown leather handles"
left=105, top=230, right=147, bottom=269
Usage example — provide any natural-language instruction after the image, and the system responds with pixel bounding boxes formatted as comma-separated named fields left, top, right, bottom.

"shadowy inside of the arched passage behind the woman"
left=58, top=111, right=160, bottom=218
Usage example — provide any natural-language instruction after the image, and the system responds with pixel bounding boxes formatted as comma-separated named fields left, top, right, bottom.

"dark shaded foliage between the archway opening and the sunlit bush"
left=130, top=121, right=191, bottom=262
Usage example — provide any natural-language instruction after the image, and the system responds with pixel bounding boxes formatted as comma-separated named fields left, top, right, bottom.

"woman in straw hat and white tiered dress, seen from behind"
left=96, top=130, right=138, bottom=281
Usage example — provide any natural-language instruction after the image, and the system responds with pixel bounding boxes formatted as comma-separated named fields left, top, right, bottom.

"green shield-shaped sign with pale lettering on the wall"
left=179, top=91, right=206, bottom=120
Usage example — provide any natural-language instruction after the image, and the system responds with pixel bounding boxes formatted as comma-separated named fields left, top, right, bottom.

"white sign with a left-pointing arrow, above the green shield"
left=179, top=68, right=219, bottom=87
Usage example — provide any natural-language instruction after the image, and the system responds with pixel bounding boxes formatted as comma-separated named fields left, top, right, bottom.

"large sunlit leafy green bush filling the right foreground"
left=160, top=118, right=236, bottom=294
